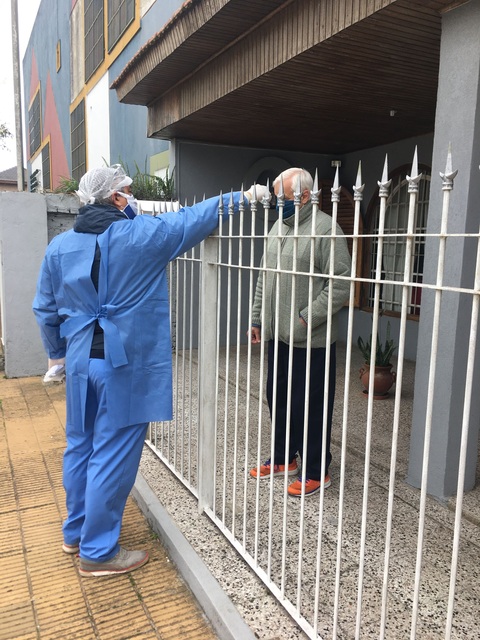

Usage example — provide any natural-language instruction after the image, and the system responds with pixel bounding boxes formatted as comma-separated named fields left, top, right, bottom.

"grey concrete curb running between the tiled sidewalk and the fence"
left=132, top=473, right=255, bottom=640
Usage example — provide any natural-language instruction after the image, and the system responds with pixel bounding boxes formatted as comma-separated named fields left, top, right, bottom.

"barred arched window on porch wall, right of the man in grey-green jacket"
left=366, top=170, right=430, bottom=316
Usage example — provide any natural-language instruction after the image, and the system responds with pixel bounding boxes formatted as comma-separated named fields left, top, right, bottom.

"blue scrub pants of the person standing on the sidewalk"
left=63, top=359, right=148, bottom=562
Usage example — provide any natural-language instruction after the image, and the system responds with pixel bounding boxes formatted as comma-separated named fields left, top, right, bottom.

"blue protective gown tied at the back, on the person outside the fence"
left=33, top=192, right=248, bottom=429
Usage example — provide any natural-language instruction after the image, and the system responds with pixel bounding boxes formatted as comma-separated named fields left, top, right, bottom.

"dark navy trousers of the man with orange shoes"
left=267, top=340, right=336, bottom=480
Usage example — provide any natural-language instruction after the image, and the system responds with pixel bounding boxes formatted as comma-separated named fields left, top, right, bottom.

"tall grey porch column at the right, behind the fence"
left=407, top=0, right=480, bottom=499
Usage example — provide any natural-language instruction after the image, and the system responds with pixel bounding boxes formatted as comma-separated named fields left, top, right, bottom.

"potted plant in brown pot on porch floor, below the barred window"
left=357, top=322, right=397, bottom=400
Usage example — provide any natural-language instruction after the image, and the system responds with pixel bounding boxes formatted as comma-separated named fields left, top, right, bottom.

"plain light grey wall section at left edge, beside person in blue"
left=0, top=192, right=48, bottom=378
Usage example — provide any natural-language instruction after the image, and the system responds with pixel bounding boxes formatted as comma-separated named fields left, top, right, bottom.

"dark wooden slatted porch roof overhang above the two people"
left=113, top=0, right=460, bottom=154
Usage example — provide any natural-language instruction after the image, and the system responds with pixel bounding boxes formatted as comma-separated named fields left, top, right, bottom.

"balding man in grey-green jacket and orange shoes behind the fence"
left=250, top=168, right=351, bottom=497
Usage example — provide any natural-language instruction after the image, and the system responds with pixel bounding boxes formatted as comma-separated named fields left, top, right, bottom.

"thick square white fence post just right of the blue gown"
left=198, top=236, right=219, bottom=512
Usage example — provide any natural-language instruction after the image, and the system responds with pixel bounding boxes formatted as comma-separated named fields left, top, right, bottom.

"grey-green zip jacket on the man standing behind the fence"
left=252, top=202, right=351, bottom=348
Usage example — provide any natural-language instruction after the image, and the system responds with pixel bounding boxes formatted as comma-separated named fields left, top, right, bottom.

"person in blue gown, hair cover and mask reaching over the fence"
left=33, top=165, right=266, bottom=576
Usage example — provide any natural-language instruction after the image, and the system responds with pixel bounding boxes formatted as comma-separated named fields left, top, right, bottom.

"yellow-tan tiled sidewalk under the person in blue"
left=0, top=375, right=216, bottom=640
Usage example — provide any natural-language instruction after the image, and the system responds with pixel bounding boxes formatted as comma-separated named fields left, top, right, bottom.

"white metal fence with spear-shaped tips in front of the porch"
left=147, top=148, right=480, bottom=639
